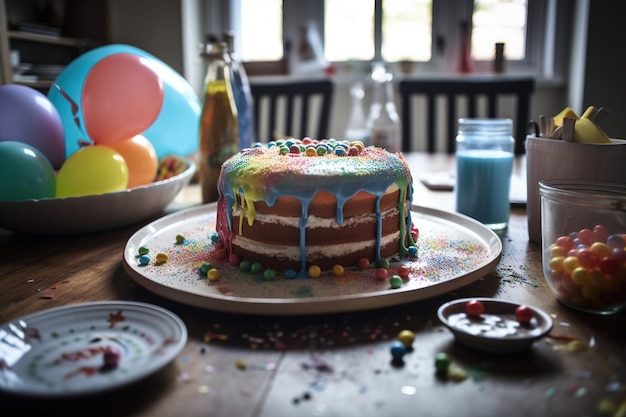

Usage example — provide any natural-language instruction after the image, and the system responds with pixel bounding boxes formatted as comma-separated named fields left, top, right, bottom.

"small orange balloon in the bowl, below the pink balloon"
left=108, top=135, right=159, bottom=188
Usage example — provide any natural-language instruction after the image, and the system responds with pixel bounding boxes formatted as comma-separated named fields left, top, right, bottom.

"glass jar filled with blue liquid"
left=455, top=118, right=515, bottom=230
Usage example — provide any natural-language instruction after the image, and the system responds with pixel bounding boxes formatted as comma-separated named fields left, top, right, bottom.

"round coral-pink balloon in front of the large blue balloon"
left=81, top=53, right=163, bottom=145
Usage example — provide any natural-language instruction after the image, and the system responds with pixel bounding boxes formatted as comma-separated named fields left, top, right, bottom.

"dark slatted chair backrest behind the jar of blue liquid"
left=398, top=77, right=535, bottom=154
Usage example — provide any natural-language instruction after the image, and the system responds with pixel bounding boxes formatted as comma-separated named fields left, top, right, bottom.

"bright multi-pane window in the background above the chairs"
left=223, top=0, right=556, bottom=74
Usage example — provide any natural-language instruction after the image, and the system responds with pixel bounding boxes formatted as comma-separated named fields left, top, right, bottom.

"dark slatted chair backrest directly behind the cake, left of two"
left=250, top=78, right=334, bottom=142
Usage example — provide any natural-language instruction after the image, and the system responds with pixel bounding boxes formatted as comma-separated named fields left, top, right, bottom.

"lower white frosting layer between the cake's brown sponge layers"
left=233, top=231, right=400, bottom=261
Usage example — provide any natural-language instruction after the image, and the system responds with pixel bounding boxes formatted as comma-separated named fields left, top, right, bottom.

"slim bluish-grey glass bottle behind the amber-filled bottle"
left=222, top=32, right=256, bottom=150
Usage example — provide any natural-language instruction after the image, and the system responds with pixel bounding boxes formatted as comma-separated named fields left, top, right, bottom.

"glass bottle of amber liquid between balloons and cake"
left=198, top=42, right=239, bottom=203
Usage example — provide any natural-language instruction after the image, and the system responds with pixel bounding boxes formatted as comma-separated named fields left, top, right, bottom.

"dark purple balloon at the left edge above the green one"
left=0, top=84, right=65, bottom=168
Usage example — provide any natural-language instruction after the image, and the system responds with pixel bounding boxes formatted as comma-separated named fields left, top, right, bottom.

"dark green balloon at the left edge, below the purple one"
left=0, top=140, right=56, bottom=201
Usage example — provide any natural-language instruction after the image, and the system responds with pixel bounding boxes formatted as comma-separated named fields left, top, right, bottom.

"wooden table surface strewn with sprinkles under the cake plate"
left=0, top=154, right=626, bottom=417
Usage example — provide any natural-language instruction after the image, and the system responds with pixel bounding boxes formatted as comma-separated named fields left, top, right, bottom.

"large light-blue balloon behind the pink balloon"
left=48, top=44, right=201, bottom=158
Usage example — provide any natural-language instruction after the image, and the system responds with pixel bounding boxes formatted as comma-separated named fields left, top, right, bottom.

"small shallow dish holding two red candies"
left=437, top=298, right=553, bottom=353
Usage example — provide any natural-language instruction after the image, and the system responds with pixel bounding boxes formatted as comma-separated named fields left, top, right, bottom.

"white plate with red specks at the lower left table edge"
left=0, top=301, right=187, bottom=398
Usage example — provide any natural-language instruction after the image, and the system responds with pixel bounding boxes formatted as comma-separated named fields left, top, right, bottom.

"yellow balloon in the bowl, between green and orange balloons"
left=56, top=145, right=128, bottom=197
